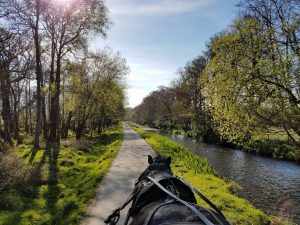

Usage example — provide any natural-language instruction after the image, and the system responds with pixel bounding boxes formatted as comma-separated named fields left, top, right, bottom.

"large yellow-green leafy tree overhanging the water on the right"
left=206, top=18, right=300, bottom=146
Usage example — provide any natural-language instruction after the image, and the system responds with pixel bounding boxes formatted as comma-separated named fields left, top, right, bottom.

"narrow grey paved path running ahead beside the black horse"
left=81, top=124, right=154, bottom=225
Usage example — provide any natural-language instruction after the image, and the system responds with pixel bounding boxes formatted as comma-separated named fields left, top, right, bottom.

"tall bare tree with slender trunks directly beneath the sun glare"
left=40, top=0, right=109, bottom=151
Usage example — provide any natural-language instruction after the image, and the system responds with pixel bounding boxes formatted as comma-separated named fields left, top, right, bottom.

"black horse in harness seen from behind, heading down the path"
left=105, top=156, right=230, bottom=225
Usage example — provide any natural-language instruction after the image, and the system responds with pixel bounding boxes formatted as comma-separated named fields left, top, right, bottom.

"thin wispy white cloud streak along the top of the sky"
left=108, top=0, right=216, bottom=16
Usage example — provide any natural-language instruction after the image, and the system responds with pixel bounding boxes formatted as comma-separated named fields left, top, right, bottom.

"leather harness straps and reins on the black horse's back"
left=105, top=171, right=231, bottom=225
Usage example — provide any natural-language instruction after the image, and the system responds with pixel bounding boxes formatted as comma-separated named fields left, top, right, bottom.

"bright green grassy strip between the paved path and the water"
left=133, top=127, right=292, bottom=225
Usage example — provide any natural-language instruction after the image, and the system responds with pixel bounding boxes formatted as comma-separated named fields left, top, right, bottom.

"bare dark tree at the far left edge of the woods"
left=0, top=28, right=32, bottom=144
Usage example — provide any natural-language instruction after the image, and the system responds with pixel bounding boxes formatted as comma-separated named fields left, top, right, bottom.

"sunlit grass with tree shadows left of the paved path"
left=0, top=125, right=123, bottom=225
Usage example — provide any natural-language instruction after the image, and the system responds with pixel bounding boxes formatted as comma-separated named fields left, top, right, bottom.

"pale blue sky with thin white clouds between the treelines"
left=92, top=0, right=239, bottom=107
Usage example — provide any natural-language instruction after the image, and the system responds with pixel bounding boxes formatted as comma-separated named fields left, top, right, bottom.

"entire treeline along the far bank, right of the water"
left=129, top=0, right=300, bottom=156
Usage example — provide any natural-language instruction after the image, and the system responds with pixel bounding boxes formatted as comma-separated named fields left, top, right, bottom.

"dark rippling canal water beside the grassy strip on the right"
left=156, top=131, right=300, bottom=225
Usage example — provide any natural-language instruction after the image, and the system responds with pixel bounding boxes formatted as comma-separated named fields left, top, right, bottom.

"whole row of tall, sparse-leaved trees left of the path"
left=0, top=0, right=128, bottom=152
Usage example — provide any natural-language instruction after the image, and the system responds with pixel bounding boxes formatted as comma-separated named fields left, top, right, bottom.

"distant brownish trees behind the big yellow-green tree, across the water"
left=131, top=56, right=215, bottom=141
